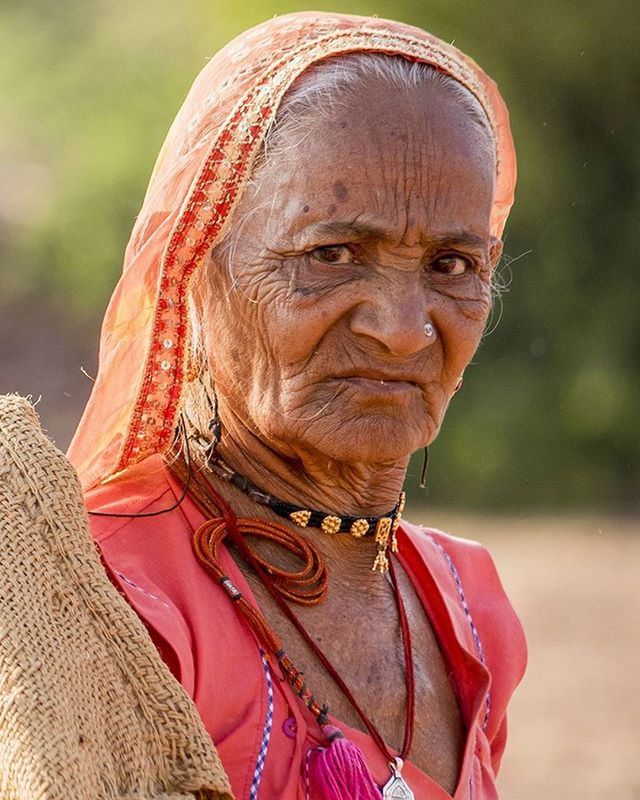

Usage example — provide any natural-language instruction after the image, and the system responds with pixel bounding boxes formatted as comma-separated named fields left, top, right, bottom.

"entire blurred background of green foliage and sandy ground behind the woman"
left=0, top=0, right=640, bottom=800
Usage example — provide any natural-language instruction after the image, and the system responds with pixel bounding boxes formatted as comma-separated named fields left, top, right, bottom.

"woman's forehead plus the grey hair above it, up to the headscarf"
left=218, top=51, right=496, bottom=249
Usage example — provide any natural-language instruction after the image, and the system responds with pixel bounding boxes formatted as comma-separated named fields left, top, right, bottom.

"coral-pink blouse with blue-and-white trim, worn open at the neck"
left=86, top=456, right=526, bottom=800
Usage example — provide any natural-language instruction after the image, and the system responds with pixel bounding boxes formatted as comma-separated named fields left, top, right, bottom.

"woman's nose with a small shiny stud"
left=350, top=287, right=437, bottom=356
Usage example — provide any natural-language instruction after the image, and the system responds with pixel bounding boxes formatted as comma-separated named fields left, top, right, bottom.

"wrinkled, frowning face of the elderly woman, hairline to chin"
left=204, top=76, right=500, bottom=464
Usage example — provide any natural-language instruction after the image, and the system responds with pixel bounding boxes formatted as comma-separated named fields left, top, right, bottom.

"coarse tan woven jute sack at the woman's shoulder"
left=0, top=395, right=232, bottom=800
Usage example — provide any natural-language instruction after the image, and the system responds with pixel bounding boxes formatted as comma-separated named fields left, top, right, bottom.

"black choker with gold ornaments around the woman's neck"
left=207, top=453, right=405, bottom=573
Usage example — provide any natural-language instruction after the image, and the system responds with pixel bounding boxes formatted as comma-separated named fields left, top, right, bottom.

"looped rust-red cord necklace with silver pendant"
left=168, top=459, right=415, bottom=800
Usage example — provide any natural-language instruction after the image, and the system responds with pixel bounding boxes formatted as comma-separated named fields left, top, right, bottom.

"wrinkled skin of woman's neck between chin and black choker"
left=212, top=414, right=408, bottom=516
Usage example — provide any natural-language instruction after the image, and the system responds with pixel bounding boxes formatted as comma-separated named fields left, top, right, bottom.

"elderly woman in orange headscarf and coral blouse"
left=70, top=13, right=525, bottom=800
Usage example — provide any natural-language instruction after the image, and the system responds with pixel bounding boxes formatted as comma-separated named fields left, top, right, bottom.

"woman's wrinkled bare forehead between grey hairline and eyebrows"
left=228, top=77, right=495, bottom=251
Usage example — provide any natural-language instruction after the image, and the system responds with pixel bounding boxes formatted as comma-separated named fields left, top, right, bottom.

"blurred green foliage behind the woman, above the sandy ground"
left=0, top=0, right=640, bottom=512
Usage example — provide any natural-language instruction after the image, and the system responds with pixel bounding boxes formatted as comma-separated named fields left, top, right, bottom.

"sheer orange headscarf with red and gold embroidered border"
left=69, top=12, right=516, bottom=489
